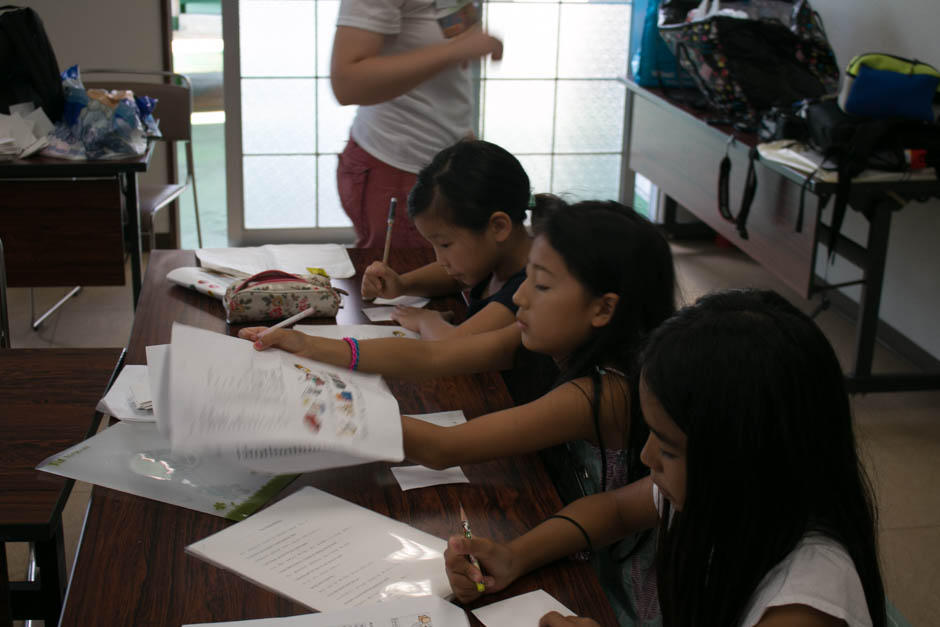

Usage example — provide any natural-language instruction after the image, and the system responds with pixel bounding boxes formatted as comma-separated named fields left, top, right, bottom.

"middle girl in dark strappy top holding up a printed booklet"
left=239, top=201, right=675, bottom=615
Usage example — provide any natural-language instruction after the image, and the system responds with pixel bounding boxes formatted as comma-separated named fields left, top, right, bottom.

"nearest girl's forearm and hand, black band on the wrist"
left=444, top=477, right=659, bottom=604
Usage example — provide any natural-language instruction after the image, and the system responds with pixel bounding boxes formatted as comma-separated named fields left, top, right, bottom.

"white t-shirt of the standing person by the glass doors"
left=336, top=0, right=473, bottom=173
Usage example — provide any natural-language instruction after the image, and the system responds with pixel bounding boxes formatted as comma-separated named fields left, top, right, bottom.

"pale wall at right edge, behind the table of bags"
left=811, top=0, right=940, bottom=359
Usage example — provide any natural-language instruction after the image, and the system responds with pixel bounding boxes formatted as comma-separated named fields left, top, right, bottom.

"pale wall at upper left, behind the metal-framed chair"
left=14, top=0, right=167, bottom=189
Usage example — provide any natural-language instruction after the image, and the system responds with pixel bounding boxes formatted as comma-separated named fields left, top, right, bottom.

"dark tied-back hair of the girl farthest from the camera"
left=408, top=139, right=529, bottom=231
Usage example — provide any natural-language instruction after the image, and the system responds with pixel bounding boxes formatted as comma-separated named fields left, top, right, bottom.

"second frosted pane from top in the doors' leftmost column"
left=242, top=78, right=316, bottom=155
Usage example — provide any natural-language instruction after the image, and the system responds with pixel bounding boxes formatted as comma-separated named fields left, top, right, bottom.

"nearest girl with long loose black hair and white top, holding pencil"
left=445, top=290, right=886, bottom=627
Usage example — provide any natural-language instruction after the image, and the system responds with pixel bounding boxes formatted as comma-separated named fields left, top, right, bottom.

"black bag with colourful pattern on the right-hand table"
left=659, top=0, right=839, bottom=127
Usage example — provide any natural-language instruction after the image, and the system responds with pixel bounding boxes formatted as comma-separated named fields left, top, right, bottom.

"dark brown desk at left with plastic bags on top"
left=0, top=144, right=153, bottom=314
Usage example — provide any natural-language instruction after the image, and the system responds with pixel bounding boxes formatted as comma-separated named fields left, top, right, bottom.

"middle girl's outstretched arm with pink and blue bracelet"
left=238, top=324, right=522, bottom=381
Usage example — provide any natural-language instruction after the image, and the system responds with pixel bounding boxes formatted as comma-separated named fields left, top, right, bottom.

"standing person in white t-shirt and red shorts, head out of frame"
left=330, top=0, right=503, bottom=248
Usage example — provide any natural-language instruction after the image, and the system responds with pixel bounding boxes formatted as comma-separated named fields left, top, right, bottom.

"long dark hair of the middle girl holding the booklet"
left=533, top=199, right=676, bottom=489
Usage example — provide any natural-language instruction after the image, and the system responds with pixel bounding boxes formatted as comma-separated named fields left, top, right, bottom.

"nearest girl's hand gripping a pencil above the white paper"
left=444, top=536, right=517, bottom=603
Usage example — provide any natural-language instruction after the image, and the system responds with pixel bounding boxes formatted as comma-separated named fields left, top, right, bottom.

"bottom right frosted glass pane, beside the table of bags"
left=552, top=154, right=621, bottom=202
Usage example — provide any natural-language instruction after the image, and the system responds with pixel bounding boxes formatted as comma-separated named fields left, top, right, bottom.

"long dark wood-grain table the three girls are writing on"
left=61, top=250, right=616, bottom=626
